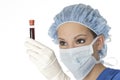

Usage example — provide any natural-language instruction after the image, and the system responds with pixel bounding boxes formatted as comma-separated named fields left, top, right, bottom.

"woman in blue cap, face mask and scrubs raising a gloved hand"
left=26, top=4, right=120, bottom=80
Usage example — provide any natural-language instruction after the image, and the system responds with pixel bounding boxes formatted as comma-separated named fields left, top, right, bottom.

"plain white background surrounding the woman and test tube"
left=0, top=0, right=120, bottom=80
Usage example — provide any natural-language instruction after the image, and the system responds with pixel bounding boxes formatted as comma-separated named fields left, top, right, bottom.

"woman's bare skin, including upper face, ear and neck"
left=57, top=22, right=105, bottom=80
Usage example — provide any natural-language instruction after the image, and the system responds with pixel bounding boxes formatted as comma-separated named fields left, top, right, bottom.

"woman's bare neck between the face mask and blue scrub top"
left=84, top=63, right=106, bottom=80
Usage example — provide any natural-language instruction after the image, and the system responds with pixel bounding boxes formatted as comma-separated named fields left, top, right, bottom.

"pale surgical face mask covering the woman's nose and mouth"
left=60, top=37, right=98, bottom=80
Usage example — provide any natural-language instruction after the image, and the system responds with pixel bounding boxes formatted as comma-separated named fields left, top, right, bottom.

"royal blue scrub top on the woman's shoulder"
left=97, top=68, right=120, bottom=80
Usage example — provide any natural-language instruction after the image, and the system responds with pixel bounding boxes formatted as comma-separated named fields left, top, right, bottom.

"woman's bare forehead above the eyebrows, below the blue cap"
left=57, top=22, right=90, bottom=36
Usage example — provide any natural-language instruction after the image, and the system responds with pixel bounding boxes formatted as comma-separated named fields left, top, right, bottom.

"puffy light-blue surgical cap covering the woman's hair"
left=48, top=4, right=110, bottom=57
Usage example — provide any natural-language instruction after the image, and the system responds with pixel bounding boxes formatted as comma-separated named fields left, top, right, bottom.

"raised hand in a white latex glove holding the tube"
left=25, top=38, right=69, bottom=80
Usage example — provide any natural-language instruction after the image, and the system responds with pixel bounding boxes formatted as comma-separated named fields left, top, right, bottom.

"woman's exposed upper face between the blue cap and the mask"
left=58, top=22, right=94, bottom=49
